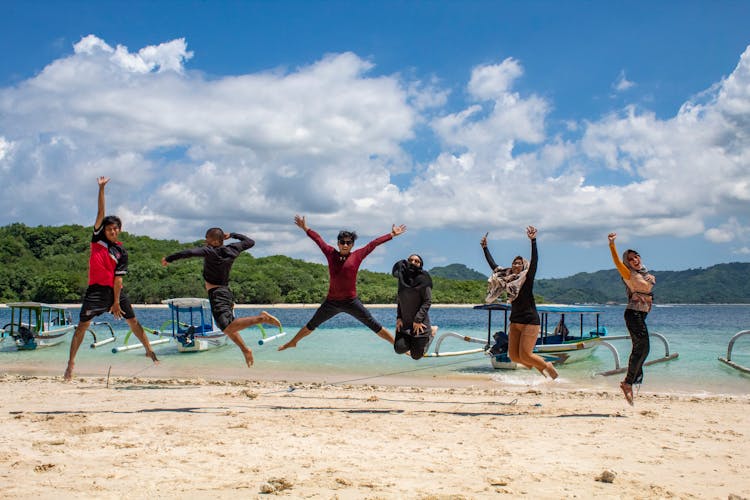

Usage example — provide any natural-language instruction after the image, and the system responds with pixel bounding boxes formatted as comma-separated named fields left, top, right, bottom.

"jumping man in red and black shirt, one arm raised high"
left=64, top=177, right=159, bottom=380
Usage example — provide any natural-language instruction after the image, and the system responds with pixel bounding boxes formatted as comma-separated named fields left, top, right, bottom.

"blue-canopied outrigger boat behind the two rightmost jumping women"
left=426, top=303, right=678, bottom=376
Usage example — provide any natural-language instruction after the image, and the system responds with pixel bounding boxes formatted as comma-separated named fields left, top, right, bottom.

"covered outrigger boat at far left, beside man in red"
left=0, top=302, right=76, bottom=351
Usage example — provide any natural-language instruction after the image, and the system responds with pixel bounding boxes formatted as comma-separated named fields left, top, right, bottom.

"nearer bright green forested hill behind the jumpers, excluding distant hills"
left=0, top=224, right=485, bottom=304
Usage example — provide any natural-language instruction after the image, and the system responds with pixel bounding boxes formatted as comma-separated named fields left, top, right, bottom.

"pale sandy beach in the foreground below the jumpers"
left=0, top=374, right=750, bottom=499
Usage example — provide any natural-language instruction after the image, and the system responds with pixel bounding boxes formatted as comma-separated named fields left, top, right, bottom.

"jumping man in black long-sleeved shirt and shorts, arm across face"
left=161, top=227, right=281, bottom=366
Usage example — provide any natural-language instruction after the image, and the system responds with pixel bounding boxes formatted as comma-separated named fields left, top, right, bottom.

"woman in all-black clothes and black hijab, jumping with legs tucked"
left=392, top=254, right=437, bottom=359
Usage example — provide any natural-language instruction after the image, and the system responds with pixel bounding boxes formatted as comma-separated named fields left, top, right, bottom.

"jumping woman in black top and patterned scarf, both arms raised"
left=480, top=226, right=557, bottom=379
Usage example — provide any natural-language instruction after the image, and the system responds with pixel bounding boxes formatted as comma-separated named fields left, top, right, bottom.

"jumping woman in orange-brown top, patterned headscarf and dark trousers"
left=608, top=233, right=656, bottom=406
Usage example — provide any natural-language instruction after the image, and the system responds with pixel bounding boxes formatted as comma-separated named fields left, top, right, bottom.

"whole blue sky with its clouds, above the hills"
left=0, top=0, right=750, bottom=277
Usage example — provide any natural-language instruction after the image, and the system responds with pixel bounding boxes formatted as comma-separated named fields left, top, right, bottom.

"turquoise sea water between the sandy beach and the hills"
left=0, top=305, right=750, bottom=394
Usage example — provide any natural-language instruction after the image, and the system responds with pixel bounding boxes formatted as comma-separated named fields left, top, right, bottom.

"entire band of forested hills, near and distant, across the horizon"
left=0, top=224, right=750, bottom=304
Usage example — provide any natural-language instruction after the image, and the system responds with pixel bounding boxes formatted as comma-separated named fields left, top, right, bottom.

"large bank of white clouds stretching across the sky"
left=0, top=35, right=750, bottom=264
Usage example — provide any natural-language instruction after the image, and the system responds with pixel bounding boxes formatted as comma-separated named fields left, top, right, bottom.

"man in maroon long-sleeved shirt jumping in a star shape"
left=279, top=215, right=406, bottom=351
